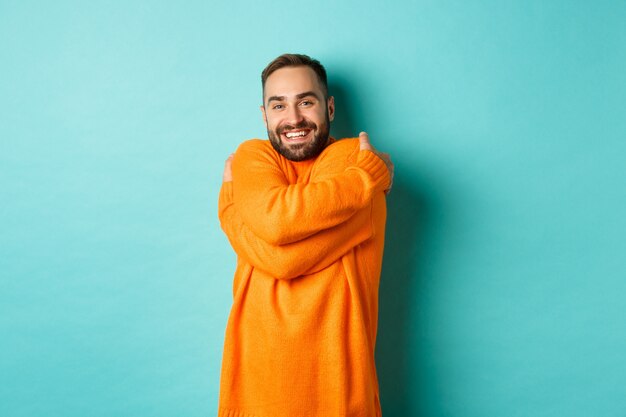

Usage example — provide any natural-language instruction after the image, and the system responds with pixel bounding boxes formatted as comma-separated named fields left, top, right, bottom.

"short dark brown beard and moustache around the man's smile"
left=267, top=112, right=330, bottom=162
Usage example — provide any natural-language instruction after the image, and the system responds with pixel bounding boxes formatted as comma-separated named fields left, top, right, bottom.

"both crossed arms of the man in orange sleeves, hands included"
left=219, top=132, right=393, bottom=279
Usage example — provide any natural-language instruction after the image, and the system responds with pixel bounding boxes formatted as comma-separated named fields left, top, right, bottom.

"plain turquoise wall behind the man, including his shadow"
left=0, top=0, right=626, bottom=417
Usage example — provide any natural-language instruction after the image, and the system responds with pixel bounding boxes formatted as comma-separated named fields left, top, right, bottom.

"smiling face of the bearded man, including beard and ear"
left=261, top=66, right=335, bottom=161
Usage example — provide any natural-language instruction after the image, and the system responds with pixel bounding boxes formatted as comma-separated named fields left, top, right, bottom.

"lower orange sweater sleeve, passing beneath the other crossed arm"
left=218, top=182, right=373, bottom=279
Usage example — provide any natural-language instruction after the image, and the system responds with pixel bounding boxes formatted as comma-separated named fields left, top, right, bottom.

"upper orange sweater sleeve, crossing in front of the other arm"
left=233, top=141, right=390, bottom=245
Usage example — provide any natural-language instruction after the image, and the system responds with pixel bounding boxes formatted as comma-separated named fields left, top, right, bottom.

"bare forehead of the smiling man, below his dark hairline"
left=263, top=66, right=322, bottom=100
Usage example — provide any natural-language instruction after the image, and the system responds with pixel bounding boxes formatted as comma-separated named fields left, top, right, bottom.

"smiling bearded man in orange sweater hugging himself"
left=219, top=54, right=393, bottom=417
